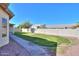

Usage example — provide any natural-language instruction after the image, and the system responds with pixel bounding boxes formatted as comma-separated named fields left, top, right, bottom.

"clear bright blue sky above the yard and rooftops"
left=9, top=3, right=79, bottom=26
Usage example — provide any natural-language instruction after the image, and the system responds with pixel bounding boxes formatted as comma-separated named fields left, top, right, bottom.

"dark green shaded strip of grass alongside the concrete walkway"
left=15, top=33, right=57, bottom=55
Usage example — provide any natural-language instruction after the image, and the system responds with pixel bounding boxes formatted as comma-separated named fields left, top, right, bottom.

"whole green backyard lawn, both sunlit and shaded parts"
left=15, top=32, right=71, bottom=47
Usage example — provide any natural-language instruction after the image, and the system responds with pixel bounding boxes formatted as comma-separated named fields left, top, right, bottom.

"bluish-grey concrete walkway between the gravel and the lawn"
left=10, top=34, right=54, bottom=56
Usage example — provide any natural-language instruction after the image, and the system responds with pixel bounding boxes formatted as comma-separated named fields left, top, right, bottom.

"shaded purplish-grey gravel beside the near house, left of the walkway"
left=0, top=40, right=30, bottom=56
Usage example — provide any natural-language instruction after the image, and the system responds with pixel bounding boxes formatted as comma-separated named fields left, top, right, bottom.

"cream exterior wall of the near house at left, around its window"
left=0, top=8, right=9, bottom=47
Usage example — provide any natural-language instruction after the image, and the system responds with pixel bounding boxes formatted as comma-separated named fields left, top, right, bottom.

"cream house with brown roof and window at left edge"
left=0, top=3, right=13, bottom=47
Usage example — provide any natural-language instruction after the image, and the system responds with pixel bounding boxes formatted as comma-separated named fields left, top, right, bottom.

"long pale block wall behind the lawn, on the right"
left=35, top=29, right=79, bottom=37
